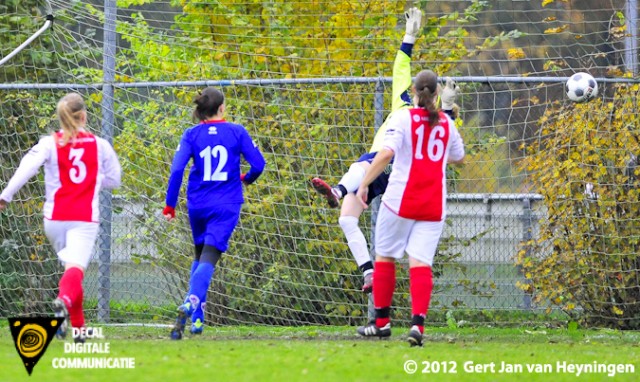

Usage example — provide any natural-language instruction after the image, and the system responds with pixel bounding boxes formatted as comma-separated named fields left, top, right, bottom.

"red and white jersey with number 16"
left=382, top=108, right=464, bottom=221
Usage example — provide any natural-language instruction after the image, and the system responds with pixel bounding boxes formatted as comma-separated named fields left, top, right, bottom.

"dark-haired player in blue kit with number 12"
left=162, top=87, right=265, bottom=339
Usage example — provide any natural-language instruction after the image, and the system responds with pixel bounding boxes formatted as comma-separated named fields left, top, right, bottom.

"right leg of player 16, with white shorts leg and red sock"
left=406, top=222, right=444, bottom=346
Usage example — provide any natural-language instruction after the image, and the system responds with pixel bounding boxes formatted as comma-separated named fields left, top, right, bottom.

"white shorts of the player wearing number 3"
left=44, top=219, right=100, bottom=269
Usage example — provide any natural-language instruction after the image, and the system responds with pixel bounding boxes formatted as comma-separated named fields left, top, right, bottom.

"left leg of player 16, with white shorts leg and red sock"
left=358, top=204, right=413, bottom=337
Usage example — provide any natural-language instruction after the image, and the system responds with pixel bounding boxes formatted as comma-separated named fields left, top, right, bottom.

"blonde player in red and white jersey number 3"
left=0, top=93, right=121, bottom=342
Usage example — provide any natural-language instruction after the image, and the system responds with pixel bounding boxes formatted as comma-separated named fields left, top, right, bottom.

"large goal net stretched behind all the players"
left=0, top=0, right=640, bottom=327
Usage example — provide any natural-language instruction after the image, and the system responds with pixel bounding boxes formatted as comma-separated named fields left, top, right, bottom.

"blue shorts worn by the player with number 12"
left=189, top=204, right=242, bottom=252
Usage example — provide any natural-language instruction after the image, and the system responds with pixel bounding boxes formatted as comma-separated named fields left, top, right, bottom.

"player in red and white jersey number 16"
left=356, top=70, right=464, bottom=346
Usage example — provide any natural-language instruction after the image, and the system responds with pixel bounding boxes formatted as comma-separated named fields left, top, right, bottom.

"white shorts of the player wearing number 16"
left=376, top=203, right=444, bottom=266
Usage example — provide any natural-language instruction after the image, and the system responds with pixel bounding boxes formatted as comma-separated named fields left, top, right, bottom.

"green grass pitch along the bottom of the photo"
left=0, top=325, right=640, bottom=382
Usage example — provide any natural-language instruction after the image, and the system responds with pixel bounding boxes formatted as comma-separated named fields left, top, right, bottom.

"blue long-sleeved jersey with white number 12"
left=166, top=120, right=265, bottom=209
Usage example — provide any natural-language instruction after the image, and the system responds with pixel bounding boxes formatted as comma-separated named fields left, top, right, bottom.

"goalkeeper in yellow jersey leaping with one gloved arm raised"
left=311, top=8, right=458, bottom=293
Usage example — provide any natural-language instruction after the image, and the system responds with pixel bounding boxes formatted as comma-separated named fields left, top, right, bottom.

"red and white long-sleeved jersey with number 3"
left=0, top=131, right=121, bottom=222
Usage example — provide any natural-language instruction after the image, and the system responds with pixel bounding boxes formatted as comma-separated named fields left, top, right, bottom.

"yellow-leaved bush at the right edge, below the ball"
left=518, top=85, right=640, bottom=330
